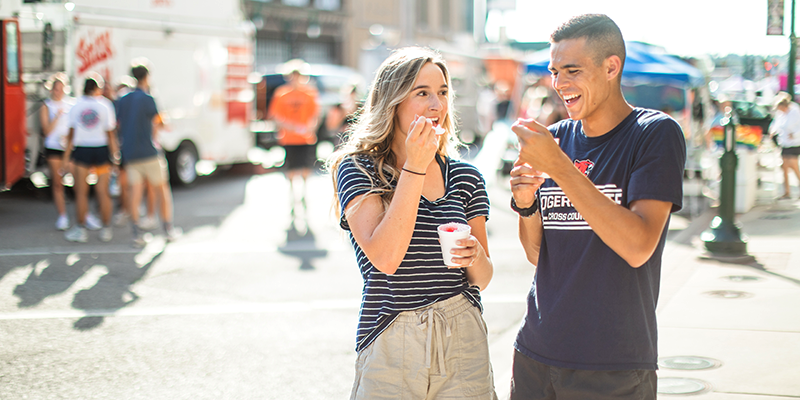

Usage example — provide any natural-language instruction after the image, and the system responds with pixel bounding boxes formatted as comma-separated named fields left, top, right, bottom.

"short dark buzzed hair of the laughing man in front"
left=550, top=14, right=625, bottom=66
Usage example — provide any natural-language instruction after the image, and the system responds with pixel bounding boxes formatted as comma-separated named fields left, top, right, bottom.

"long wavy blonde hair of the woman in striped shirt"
left=327, top=47, right=461, bottom=216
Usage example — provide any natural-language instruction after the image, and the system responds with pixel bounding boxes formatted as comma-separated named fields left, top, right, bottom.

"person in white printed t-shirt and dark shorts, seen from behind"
left=64, top=73, right=119, bottom=242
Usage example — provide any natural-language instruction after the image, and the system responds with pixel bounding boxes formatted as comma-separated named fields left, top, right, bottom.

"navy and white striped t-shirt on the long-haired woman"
left=337, top=156, right=489, bottom=351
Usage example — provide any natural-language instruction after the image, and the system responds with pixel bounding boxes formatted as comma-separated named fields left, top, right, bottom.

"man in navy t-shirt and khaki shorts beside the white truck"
left=117, top=65, right=181, bottom=247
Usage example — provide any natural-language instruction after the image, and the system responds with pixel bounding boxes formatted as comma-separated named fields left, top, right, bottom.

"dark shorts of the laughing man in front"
left=511, top=350, right=657, bottom=400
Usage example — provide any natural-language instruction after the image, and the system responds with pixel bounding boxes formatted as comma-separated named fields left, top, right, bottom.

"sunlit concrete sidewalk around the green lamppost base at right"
left=490, top=200, right=800, bottom=400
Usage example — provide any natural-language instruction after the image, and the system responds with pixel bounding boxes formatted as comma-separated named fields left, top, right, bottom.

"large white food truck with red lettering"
left=15, top=0, right=255, bottom=184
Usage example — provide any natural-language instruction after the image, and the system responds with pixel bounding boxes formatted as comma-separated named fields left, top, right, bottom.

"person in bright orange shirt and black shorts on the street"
left=268, top=60, right=320, bottom=216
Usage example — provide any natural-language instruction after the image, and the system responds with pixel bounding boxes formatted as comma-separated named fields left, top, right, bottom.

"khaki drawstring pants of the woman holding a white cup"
left=350, top=295, right=497, bottom=400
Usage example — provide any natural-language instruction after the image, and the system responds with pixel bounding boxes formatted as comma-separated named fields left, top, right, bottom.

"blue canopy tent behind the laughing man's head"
left=526, top=42, right=703, bottom=89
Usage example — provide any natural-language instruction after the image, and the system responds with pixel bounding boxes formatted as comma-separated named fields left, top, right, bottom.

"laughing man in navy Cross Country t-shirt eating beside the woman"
left=511, top=15, right=686, bottom=400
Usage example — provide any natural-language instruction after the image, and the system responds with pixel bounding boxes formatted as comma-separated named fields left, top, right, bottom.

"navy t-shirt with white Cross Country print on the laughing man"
left=515, top=108, right=686, bottom=370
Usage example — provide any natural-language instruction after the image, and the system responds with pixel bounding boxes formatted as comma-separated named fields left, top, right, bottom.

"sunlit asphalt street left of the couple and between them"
left=0, top=164, right=533, bottom=400
